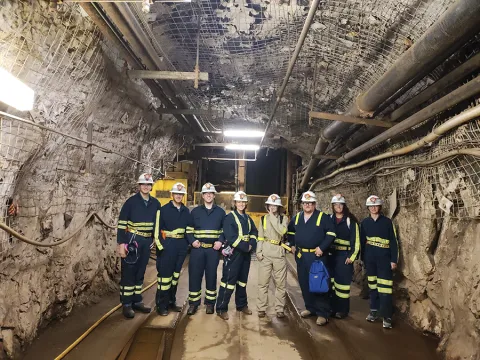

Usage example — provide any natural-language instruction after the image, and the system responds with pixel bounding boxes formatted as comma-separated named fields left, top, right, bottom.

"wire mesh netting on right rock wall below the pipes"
left=315, top=100, right=480, bottom=219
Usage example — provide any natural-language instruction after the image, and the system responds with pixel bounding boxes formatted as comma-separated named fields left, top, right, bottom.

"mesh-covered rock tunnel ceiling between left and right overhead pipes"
left=125, top=0, right=453, bottom=156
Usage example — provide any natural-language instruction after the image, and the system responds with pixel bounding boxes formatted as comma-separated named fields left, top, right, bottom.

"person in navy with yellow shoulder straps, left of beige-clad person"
left=216, top=191, right=258, bottom=320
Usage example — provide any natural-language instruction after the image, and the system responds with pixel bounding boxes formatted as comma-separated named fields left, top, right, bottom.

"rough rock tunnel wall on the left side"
left=0, top=1, right=181, bottom=357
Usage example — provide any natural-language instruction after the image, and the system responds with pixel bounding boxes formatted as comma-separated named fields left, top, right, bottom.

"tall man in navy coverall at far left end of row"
left=117, top=173, right=160, bottom=319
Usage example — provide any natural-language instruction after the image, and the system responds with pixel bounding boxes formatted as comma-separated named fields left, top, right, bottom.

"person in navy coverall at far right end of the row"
left=360, top=195, right=399, bottom=329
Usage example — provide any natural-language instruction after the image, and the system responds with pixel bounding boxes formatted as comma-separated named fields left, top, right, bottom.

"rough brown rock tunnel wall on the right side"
left=315, top=105, right=480, bottom=360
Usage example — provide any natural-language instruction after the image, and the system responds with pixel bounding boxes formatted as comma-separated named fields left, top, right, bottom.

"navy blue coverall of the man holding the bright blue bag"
left=287, top=210, right=335, bottom=319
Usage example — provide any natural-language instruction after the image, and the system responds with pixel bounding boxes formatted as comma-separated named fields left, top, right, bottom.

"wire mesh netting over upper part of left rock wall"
left=0, top=0, right=171, bottom=255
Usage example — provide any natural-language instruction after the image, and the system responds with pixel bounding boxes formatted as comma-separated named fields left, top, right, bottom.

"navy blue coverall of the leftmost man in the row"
left=117, top=192, right=160, bottom=305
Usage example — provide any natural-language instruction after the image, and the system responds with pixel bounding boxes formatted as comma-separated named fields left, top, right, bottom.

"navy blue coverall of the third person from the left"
left=187, top=204, right=225, bottom=306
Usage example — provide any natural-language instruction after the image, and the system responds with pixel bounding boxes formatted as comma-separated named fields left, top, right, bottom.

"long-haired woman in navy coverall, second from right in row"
left=330, top=194, right=360, bottom=319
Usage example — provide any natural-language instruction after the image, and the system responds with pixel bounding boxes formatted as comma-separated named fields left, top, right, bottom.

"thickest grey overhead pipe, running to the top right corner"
left=300, top=0, right=480, bottom=189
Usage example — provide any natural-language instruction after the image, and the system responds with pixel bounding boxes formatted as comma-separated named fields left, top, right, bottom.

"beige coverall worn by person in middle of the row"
left=257, top=214, right=288, bottom=312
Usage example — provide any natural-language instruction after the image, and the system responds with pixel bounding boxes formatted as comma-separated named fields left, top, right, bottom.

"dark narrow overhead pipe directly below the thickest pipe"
left=344, top=53, right=480, bottom=151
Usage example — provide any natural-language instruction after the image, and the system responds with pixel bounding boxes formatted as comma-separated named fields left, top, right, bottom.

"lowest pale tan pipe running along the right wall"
left=310, top=105, right=480, bottom=190
